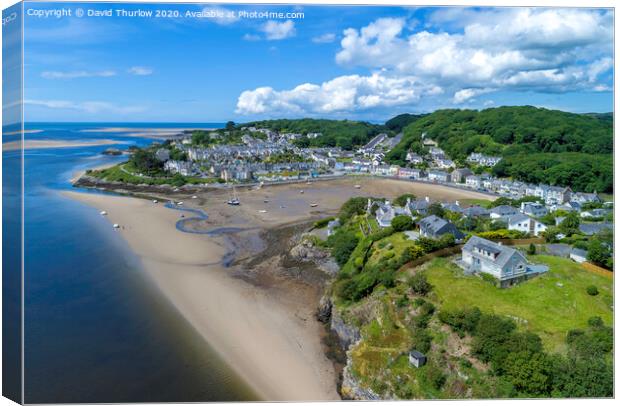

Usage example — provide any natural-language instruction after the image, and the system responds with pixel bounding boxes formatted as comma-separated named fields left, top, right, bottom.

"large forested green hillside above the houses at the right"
left=386, top=106, right=613, bottom=192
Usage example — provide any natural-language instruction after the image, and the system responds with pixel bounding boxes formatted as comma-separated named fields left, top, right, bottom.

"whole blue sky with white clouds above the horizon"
left=24, top=2, right=613, bottom=122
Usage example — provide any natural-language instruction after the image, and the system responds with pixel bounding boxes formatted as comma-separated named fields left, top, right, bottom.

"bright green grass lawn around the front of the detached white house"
left=425, top=255, right=613, bottom=352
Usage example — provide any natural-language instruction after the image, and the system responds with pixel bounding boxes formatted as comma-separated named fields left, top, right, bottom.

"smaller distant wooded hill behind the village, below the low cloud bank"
left=244, top=118, right=384, bottom=150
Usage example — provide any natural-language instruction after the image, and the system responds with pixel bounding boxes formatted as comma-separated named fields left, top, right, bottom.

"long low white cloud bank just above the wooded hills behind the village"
left=236, top=73, right=442, bottom=115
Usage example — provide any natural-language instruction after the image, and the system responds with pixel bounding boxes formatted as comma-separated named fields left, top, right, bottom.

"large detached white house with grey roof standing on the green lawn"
left=456, top=236, right=548, bottom=287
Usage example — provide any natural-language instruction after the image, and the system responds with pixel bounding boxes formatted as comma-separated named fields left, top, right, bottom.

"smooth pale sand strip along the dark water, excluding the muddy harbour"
left=65, top=192, right=339, bottom=401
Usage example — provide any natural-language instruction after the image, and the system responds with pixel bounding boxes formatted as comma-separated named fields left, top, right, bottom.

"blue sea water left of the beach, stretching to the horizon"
left=5, top=123, right=256, bottom=403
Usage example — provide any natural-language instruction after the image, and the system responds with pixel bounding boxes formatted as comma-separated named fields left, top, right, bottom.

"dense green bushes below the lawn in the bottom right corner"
left=439, top=309, right=613, bottom=397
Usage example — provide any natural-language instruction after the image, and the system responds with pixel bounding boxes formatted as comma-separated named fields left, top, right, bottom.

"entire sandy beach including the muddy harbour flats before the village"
left=66, top=177, right=492, bottom=401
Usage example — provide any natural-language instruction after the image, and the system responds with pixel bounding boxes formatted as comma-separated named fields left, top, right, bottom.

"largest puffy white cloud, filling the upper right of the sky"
left=336, top=8, right=613, bottom=91
